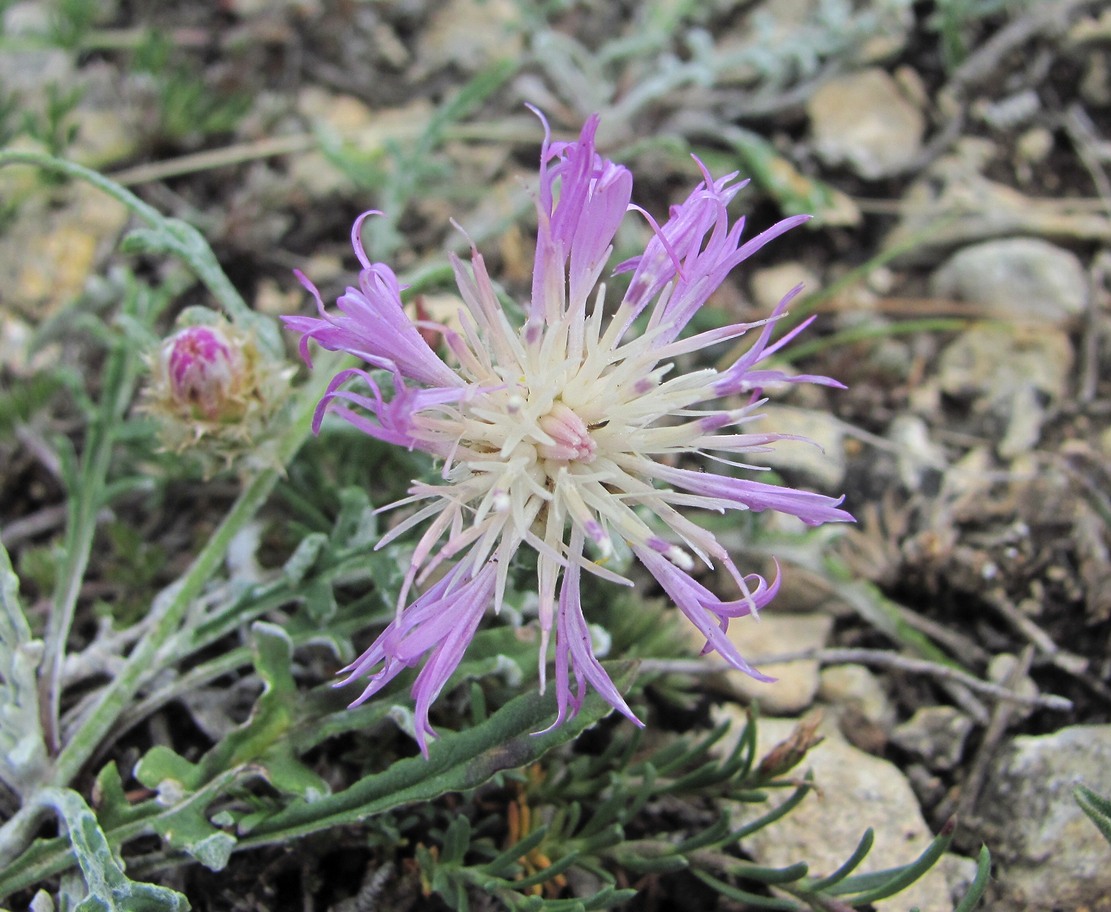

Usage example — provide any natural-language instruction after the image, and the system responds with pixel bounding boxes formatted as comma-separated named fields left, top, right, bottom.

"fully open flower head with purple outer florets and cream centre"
left=284, top=117, right=852, bottom=751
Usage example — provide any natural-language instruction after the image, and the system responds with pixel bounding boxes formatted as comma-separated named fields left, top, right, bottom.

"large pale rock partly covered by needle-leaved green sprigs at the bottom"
left=720, top=718, right=968, bottom=912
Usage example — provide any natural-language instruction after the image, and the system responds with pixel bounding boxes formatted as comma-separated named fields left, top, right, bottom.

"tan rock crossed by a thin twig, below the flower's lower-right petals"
left=691, top=611, right=833, bottom=715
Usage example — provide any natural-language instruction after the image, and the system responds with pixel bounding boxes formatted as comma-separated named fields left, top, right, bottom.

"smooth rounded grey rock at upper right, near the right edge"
left=930, top=238, right=1088, bottom=325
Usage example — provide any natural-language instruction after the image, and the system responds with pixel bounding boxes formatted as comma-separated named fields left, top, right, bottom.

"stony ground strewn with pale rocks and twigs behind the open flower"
left=0, top=0, right=1111, bottom=912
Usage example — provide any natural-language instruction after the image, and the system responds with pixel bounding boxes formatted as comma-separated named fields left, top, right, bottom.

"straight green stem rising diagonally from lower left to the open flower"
left=51, top=355, right=340, bottom=785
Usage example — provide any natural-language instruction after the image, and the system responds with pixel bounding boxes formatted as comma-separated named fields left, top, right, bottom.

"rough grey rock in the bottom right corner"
left=975, top=724, right=1111, bottom=912
